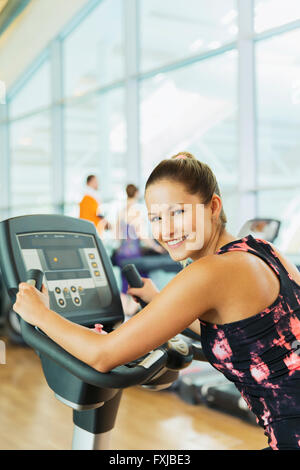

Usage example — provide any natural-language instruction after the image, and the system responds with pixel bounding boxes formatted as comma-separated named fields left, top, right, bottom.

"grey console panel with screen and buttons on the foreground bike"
left=17, top=232, right=112, bottom=315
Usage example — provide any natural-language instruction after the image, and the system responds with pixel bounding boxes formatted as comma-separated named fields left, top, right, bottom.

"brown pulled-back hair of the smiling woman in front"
left=145, top=152, right=227, bottom=228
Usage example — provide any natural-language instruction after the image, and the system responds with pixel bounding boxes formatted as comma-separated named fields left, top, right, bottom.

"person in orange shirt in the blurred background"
left=79, top=175, right=109, bottom=236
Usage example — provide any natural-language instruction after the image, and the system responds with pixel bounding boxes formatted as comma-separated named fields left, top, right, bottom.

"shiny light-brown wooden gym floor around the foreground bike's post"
left=0, top=345, right=267, bottom=450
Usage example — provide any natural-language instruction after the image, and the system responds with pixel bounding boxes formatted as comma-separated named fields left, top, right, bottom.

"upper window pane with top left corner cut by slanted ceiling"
left=63, top=0, right=124, bottom=96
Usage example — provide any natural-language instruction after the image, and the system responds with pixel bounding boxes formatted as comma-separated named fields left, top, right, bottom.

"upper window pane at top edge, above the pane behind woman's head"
left=140, top=0, right=238, bottom=71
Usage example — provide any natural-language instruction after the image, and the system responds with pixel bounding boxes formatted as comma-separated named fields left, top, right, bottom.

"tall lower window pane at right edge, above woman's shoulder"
left=256, top=29, right=300, bottom=253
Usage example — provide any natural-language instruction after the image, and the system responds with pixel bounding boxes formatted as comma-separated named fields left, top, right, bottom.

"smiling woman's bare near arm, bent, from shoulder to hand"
left=14, top=256, right=218, bottom=372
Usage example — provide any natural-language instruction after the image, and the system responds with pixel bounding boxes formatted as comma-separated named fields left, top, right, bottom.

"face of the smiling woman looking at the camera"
left=145, top=180, right=222, bottom=261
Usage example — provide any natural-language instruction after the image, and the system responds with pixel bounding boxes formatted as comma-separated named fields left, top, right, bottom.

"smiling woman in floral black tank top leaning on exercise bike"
left=14, top=153, right=300, bottom=450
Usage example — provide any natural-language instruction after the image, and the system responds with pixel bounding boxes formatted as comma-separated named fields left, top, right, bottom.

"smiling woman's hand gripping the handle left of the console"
left=13, top=282, right=49, bottom=326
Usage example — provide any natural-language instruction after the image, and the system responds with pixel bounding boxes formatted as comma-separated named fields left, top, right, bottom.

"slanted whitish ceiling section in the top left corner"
left=0, top=0, right=89, bottom=90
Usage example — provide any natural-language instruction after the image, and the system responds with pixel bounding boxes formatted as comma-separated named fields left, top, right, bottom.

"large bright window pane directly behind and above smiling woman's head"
left=141, top=51, right=238, bottom=231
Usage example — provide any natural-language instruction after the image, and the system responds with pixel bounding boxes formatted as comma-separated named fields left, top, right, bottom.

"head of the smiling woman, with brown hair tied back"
left=145, top=152, right=227, bottom=261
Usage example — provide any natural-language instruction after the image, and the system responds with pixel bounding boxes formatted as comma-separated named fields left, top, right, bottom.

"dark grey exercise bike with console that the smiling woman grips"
left=0, top=215, right=202, bottom=449
